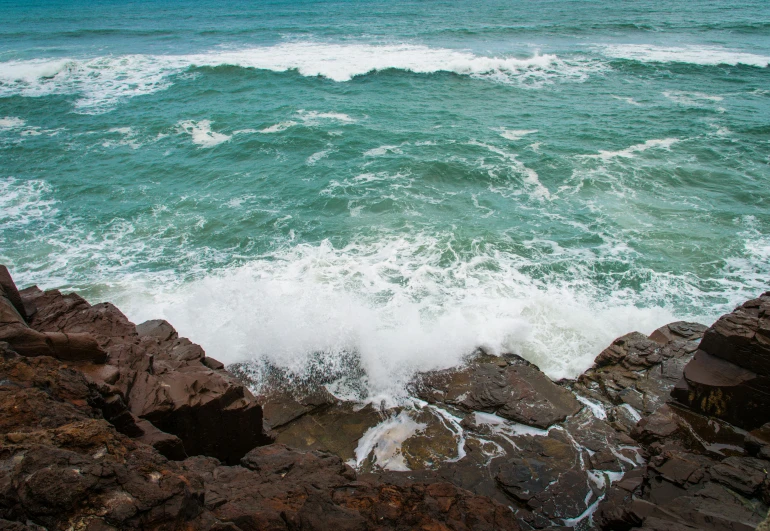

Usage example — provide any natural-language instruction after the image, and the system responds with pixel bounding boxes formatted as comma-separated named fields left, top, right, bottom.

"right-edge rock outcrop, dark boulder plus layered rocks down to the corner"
left=594, top=302, right=770, bottom=531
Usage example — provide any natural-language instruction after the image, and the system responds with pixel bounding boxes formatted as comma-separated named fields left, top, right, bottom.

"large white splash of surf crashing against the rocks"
left=106, top=235, right=674, bottom=402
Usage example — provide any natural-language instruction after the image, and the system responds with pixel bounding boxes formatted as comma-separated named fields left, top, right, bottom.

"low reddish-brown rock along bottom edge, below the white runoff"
left=184, top=444, right=519, bottom=530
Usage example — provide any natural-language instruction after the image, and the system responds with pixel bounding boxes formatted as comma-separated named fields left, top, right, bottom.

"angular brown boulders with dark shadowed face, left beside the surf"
left=20, top=288, right=270, bottom=463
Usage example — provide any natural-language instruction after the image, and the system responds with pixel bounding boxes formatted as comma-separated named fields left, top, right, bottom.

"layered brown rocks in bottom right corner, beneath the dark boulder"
left=594, top=405, right=770, bottom=531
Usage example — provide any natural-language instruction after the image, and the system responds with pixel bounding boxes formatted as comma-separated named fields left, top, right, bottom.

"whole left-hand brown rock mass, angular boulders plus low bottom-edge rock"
left=0, top=267, right=520, bottom=531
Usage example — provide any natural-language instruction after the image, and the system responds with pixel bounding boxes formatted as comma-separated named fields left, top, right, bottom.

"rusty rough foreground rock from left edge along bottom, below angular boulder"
left=0, top=343, right=519, bottom=531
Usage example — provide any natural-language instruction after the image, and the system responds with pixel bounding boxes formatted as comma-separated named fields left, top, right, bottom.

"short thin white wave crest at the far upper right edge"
left=601, top=44, right=770, bottom=67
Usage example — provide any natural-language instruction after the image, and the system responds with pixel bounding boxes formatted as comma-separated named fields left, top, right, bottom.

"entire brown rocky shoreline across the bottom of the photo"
left=0, top=266, right=770, bottom=531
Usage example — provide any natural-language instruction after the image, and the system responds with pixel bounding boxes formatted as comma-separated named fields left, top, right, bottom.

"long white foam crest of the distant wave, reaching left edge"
left=0, top=42, right=604, bottom=113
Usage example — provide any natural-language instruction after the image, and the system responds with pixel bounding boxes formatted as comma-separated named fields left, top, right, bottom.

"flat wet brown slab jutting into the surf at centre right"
left=415, top=358, right=581, bottom=428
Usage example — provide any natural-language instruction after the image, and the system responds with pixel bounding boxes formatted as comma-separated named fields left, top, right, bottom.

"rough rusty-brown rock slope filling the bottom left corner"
left=0, top=344, right=207, bottom=529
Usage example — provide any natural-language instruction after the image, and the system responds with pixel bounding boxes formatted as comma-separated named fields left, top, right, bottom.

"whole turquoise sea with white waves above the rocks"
left=0, top=0, right=770, bottom=398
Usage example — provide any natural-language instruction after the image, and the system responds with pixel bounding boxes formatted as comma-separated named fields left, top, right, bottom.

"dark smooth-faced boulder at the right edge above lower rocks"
left=673, top=292, right=770, bottom=430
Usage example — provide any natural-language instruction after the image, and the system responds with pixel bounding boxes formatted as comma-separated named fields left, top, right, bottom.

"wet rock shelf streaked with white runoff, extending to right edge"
left=255, top=294, right=770, bottom=531
